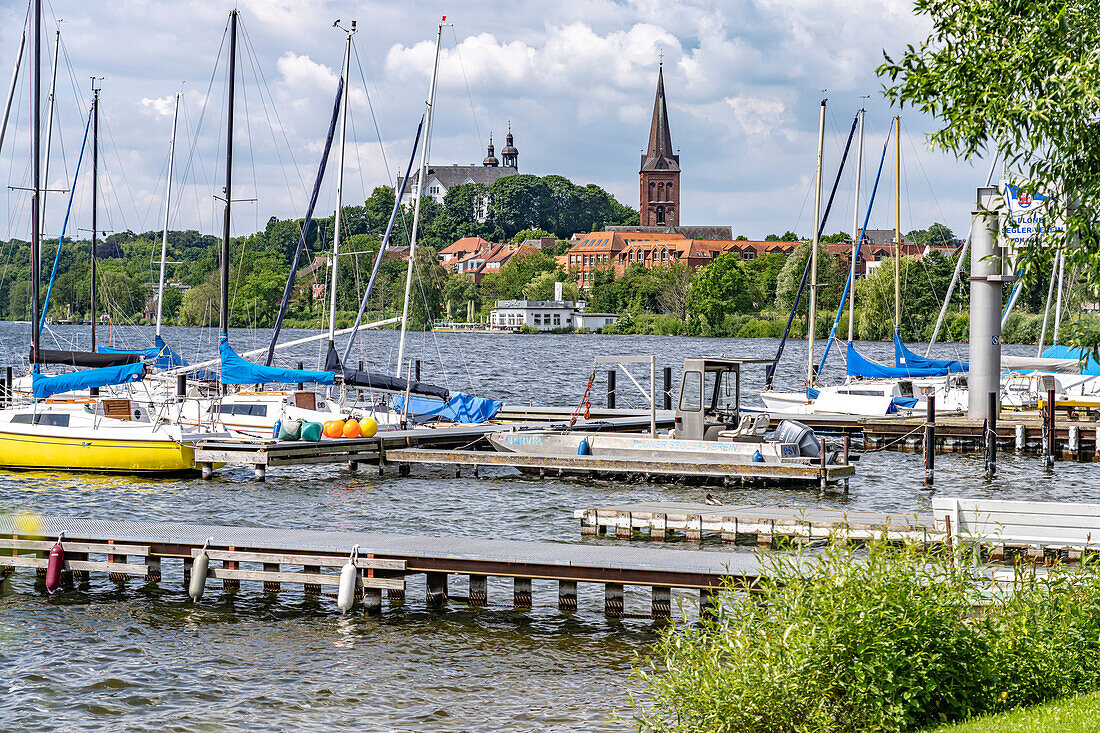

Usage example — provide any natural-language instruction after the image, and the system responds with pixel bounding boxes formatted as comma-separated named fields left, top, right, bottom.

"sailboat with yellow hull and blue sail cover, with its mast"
left=0, top=0, right=205, bottom=472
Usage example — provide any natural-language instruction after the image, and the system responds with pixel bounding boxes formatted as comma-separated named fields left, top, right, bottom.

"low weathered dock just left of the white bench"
left=573, top=502, right=945, bottom=547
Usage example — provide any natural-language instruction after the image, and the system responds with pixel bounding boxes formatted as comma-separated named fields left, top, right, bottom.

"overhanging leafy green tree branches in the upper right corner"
left=878, top=0, right=1100, bottom=343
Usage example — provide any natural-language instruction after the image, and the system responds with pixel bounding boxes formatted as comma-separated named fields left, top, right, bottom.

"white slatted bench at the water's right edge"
left=932, top=497, right=1100, bottom=559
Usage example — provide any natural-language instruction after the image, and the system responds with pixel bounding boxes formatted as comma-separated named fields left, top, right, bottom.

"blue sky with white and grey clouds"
left=0, top=0, right=987, bottom=239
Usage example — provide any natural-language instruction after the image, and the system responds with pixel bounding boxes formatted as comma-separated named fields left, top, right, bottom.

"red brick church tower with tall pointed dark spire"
left=638, top=63, right=680, bottom=227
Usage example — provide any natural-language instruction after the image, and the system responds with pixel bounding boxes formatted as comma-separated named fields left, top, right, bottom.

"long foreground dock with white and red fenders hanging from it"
left=0, top=516, right=762, bottom=617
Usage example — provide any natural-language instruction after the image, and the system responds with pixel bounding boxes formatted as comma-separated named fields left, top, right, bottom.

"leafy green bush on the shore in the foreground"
left=636, top=544, right=1100, bottom=733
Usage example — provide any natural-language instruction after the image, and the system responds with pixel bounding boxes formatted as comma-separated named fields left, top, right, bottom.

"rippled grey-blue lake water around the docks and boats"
left=0, top=324, right=1097, bottom=731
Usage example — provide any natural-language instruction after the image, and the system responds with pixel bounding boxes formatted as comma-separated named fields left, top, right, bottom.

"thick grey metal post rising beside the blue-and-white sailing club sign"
left=967, top=186, right=1003, bottom=420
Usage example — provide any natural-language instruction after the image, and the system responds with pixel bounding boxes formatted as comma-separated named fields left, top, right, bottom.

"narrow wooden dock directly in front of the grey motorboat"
left=385, top=448, right=856, bottom=486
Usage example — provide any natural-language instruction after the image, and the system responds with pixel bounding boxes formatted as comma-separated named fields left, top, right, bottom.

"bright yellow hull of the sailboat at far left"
left=0, top=431, right=196, bottom=473
